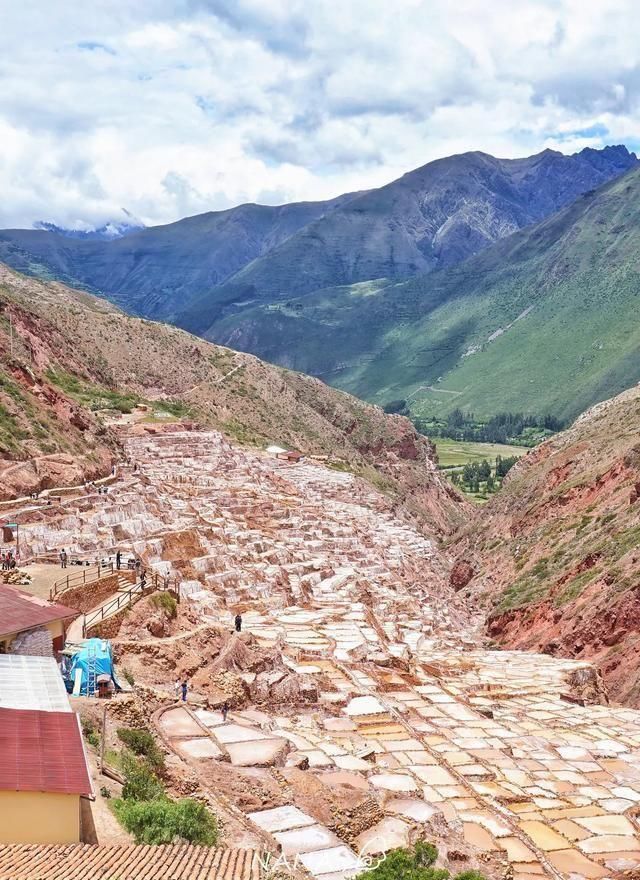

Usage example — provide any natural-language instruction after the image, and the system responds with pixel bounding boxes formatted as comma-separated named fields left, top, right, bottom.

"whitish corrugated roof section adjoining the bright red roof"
left=0, top=654, right=71, bottom=712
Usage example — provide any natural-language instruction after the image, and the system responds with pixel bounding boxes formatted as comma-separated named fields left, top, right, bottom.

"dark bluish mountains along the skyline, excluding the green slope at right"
left=0, top=146, right=638, bottom=333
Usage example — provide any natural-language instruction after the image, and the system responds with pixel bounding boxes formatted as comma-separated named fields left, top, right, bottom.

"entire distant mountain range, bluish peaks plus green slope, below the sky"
left=0, top=146, right=639, bottom=418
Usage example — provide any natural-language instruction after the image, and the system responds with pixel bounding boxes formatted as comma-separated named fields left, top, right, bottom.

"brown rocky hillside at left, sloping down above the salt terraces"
left=0, top=265, right=466, bottom=533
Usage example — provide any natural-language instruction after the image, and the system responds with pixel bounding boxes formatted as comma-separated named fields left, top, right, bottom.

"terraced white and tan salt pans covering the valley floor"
left=12, top=426, right=640, bottom=880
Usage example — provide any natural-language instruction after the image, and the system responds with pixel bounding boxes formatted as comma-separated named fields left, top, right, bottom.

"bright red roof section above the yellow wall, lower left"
left=0, top=709, right=92, bottom=794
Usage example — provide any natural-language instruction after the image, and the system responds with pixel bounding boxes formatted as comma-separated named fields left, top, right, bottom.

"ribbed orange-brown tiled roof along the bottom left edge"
left=0, top=843, right=261, bottom=880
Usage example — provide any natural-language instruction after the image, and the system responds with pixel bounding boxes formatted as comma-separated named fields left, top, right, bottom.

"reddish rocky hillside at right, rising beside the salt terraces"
left=454, top=386, right=640, bottom=706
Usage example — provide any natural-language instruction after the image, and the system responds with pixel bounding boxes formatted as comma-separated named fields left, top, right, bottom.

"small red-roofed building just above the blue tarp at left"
left=0, top=584, right=79, bottom=654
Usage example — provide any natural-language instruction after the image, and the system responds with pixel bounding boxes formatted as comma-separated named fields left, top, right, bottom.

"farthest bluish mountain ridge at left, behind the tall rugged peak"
left=0, top=193, right=354, bottom=319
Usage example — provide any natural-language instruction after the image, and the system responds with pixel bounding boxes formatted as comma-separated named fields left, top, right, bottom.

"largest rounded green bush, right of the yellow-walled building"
left=114, top=798, right=218, bottom=846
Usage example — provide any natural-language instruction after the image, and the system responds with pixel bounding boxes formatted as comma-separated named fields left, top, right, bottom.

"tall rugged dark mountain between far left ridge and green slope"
left=176, top=146, right=637, bottom=333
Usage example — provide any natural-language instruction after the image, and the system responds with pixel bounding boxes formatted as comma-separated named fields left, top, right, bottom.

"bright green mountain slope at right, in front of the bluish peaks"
left=207, top=170, right=640, bottom=426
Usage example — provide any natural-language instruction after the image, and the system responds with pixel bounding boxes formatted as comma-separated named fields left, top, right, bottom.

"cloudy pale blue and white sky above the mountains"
left=0, top=0, right=640, bottom=229
